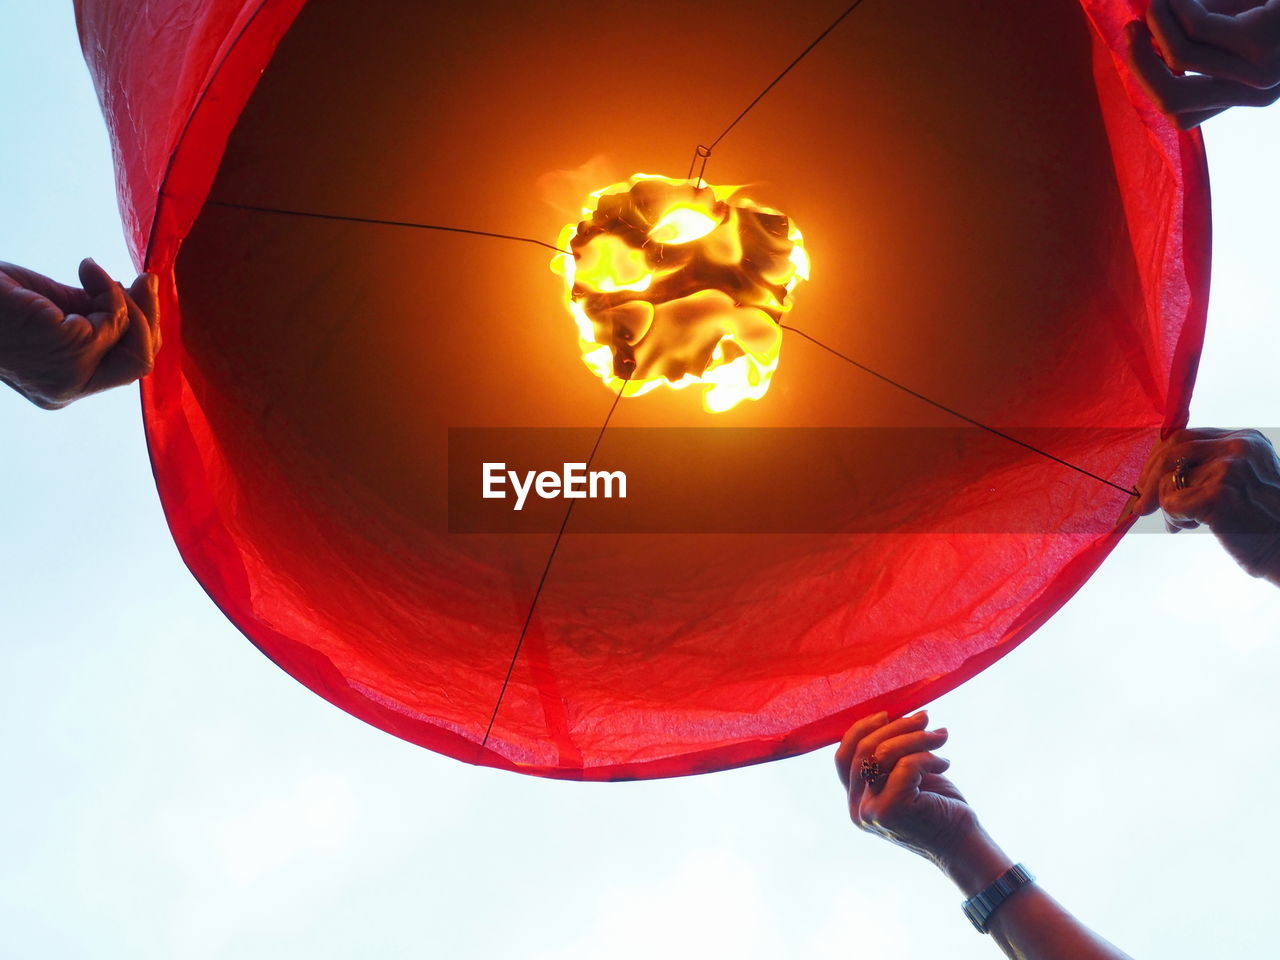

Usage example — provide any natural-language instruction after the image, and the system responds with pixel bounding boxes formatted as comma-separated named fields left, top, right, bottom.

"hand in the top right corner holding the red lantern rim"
left=1129, top=0, right=1280, bottom=129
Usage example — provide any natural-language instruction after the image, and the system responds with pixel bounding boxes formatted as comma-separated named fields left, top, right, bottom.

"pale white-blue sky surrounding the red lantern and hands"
left=0, top=0, right=1280, bottom=960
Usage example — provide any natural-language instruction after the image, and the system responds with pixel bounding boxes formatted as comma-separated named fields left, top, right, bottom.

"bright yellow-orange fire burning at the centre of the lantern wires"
left=552, top=173, right=809, bottom=413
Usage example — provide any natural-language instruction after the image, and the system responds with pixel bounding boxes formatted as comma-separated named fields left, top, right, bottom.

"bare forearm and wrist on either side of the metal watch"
left=936, top=827, right=1130, bottom=960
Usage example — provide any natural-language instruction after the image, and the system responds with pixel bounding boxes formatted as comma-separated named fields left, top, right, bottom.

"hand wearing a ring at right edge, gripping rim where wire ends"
left=1133, top=430, right=1280, bottom=585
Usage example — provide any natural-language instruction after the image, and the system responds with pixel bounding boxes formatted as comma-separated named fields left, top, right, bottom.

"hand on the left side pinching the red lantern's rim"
left=0, top=260, right=160, bottom=410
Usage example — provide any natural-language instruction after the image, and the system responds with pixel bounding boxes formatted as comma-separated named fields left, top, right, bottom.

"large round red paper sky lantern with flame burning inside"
left=77, top=0, right=1210, bottom=780
